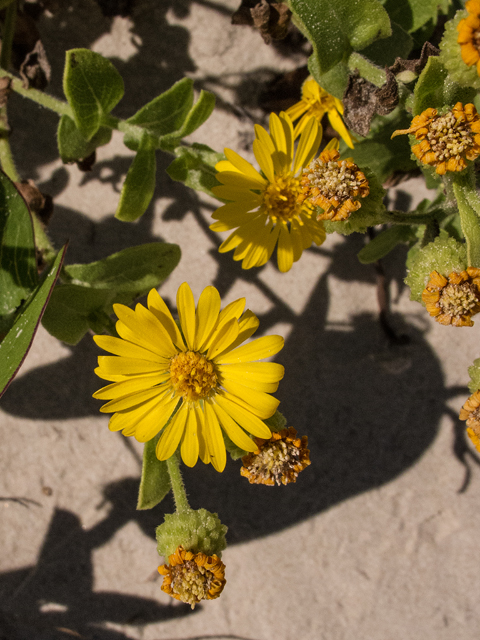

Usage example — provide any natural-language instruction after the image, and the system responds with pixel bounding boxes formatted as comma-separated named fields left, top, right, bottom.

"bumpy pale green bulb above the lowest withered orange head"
left=156, top=509, right=228, bottom=558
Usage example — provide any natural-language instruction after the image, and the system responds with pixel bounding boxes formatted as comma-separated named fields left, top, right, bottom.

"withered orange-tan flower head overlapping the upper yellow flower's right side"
left=299, top=148, right=370, bottom=222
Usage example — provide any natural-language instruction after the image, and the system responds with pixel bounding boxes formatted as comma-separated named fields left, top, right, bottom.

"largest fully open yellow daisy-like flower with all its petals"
left=94, top=282, right=284, bottom=471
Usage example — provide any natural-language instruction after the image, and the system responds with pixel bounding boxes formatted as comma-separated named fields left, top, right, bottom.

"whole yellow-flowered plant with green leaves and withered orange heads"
left=0, top=0, right=480, bottom=607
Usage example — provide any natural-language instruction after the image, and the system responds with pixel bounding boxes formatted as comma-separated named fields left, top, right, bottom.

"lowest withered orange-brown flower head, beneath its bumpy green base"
left=158, top=547, right=227, bottom=609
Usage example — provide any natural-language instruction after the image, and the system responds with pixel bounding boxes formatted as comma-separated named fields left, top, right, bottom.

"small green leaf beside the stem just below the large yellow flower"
left=137, top=434, right=172, bottom=510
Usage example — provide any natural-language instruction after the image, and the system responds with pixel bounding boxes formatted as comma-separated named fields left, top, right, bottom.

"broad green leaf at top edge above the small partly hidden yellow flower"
left=288, top=0, right=392, bottom=75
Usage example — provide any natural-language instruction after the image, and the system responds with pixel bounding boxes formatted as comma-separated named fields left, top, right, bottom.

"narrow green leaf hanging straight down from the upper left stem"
left=115, top=133, right=157, bottom=222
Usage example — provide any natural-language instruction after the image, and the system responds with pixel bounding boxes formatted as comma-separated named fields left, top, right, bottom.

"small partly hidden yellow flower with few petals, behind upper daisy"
left=286, top=76, right=353, bottom=149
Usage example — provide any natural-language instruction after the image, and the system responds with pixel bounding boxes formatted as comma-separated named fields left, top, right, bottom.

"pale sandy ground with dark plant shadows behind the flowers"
left=0, top=0, right=480, bottom=640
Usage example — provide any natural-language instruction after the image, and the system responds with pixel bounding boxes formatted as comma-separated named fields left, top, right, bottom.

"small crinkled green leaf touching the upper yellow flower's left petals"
left=167, top=142, right=225, bottom=197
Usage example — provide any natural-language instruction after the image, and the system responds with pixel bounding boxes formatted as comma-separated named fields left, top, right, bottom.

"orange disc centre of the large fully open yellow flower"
left=170, top=351, right=218, bottom=401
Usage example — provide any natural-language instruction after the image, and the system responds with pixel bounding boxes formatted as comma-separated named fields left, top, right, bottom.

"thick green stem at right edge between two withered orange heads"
left=450, top=170, right=480, bottom=268
